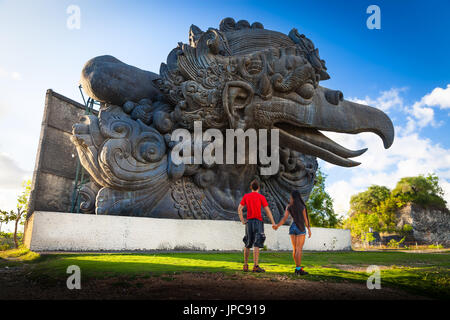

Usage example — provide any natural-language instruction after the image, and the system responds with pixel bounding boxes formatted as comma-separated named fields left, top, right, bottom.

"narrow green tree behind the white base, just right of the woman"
left=306, top=168, right=340, bottom=228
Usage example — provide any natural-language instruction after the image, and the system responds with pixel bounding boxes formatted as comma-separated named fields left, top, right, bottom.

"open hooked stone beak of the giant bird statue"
left=263, top=87, right=394, bottom=167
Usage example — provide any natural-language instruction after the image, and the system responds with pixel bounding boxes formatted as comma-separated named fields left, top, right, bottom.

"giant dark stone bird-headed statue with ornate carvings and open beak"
left=72, top=18, right=394, bottom=220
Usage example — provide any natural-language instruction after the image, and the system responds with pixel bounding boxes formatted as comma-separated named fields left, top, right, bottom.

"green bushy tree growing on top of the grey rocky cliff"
left=392, top=174, right=447, bottom=208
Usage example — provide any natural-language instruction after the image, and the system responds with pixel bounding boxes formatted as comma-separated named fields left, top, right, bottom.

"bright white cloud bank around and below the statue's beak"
left=323, top=86, right=450, bottom=214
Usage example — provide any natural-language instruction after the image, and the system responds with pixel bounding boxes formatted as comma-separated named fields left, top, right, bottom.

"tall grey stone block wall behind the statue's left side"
left=28, top=89, right=96, bottom=217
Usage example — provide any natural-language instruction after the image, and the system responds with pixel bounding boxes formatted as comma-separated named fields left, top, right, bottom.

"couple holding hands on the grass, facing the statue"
left=238, top=180, right=311, bottom=275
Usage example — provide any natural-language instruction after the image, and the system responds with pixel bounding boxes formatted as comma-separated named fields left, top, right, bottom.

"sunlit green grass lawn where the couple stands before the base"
left=0, top=249, right=450, bottom=299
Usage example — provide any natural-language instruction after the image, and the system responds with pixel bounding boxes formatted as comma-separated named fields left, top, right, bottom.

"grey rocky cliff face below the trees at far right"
left=397, top=204, right=450, bottom=247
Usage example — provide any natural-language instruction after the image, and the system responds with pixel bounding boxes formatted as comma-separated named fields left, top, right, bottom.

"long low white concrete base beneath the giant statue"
left=24, top=212, right=351, bottom=251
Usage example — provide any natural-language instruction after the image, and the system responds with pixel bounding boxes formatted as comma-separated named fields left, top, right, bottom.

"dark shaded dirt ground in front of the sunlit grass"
left=0, top=267, right=424, bottom=300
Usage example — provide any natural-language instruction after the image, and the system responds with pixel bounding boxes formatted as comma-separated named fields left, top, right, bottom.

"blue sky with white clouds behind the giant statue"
left=0, top=0, right=450, bottom=225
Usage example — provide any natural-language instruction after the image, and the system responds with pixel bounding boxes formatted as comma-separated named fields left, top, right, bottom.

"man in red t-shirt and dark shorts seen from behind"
left=238, top=180, right=275, bottom=272
